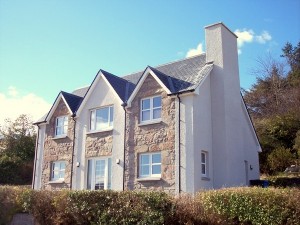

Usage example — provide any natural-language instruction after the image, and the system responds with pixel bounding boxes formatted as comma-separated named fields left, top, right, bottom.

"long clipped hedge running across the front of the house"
left=0, top=186, right=300, bottom=225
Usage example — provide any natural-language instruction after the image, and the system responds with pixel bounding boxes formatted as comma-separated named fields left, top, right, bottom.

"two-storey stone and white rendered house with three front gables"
left=33, top=23, right=261, bottom=193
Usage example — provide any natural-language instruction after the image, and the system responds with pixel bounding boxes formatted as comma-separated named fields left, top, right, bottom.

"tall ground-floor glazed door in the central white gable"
left=87, top=158, right=111, bottom=190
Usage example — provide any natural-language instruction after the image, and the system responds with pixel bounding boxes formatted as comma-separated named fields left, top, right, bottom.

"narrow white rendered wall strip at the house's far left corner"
left=34, top=124, right=46, bottom=190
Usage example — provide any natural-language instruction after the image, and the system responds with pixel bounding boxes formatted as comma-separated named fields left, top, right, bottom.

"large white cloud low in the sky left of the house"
left=0, top=86, right=51, bottom=124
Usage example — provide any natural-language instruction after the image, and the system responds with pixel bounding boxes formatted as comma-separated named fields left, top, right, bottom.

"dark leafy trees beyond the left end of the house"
left=0, top=115, right=36, bottom=184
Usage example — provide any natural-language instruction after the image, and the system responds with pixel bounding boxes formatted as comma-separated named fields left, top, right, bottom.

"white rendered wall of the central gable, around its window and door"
left=74, top=77, right=125, bottom=190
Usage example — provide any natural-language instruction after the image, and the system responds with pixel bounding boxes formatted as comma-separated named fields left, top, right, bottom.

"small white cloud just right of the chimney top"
left=234, top=29, right=272, bottom=54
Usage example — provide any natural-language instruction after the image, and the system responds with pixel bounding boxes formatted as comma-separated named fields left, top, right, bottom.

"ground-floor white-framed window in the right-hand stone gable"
left=139, top=153, right=161, bottom=178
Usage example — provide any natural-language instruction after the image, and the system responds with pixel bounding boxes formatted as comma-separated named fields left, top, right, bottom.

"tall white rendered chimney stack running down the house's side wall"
left=206, top=23, right=257, bottom=188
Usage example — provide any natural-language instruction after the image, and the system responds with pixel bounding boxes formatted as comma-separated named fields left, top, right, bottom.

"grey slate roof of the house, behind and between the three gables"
left=36, top=54, right=213, bottom=123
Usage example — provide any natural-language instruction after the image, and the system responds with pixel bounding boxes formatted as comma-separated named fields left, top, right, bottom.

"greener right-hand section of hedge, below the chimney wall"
left=197, top=187, right=300, bottom=225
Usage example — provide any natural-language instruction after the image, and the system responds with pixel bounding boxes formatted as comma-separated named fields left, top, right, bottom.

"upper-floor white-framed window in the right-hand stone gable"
left=141, top=96, right=161, bottom=122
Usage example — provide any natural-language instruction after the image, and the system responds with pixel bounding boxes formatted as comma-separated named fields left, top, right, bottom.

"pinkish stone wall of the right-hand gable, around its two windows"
left=125, top=75, right=175, bottom=193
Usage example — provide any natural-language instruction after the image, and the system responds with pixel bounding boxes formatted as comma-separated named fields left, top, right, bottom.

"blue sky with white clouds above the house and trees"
left=0, top=0, right=300, bottom=125
